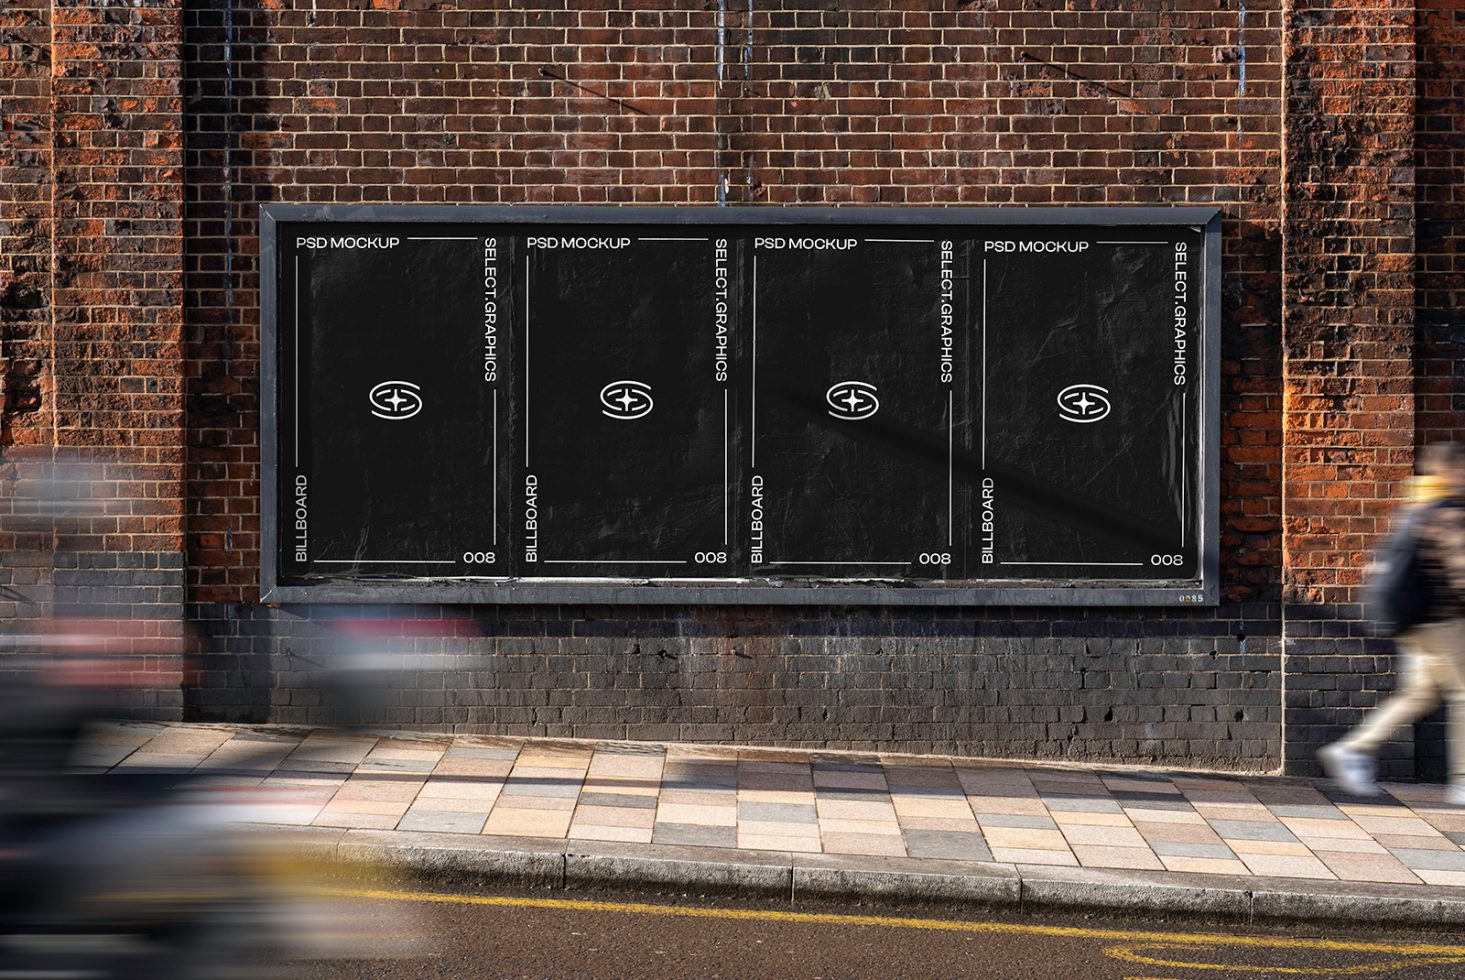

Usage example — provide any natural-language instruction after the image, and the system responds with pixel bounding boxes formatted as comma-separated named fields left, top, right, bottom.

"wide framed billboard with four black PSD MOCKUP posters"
left=262, top=205, right=1219, bottom=604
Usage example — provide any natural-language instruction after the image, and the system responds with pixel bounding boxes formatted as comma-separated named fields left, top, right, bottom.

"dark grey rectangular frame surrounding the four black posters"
left=259, top=204, right=1222, bottom=606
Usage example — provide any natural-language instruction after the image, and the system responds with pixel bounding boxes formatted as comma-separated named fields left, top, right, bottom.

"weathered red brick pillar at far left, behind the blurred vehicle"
left=0, top=0, right=183, bottom=718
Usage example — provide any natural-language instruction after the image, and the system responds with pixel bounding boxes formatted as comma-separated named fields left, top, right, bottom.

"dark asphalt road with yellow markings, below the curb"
left=300, top=885, right=1465, bottom=980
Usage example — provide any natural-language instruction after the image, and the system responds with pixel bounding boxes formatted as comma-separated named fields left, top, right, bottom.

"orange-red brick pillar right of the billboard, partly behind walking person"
left=1282, top=0, right=1415, bottom=775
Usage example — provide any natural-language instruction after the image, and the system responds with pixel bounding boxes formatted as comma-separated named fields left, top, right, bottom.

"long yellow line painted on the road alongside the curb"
left=311, top=888, right=1465, bottom=958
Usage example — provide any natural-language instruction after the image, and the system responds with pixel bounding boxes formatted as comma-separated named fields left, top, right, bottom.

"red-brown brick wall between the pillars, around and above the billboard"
left=186, top=0, right=1282, bottom=602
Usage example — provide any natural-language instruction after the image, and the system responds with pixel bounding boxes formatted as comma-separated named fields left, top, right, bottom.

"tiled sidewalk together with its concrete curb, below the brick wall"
left=79, top=722, right=1465, bottom=926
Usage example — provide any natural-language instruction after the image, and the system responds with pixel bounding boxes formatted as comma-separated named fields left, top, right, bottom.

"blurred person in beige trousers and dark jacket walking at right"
left=1319, top=442, right=1465, bottom=806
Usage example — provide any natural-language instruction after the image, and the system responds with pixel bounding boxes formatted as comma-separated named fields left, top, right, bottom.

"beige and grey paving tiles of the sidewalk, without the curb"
left=79, top=724, right=1465, bottom=885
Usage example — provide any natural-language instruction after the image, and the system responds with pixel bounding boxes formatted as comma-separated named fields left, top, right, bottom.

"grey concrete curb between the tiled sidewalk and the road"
left=253, top=825, right=1465, bottom=927
